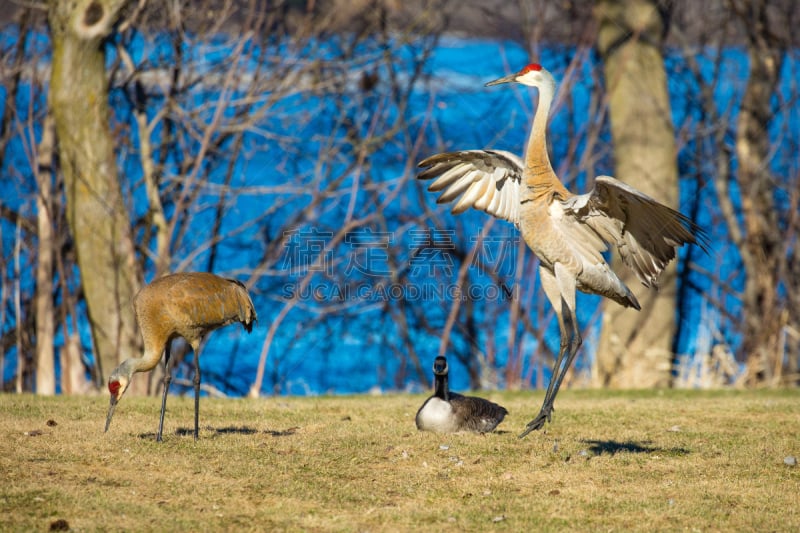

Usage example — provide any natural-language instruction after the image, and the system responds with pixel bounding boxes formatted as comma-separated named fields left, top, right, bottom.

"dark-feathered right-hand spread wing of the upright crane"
left=562, top=176, right=707, bottom=287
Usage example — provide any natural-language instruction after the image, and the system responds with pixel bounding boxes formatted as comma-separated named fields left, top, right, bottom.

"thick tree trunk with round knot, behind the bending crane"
left=49, top=0, right=139, bottom=390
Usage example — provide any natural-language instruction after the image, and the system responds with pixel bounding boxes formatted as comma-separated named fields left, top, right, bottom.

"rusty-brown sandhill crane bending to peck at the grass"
left=105, top=272, right=257, bottom=442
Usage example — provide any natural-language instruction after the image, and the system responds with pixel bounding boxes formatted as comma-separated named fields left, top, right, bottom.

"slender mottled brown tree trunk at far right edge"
left=731, top=0, right=786, bottom=385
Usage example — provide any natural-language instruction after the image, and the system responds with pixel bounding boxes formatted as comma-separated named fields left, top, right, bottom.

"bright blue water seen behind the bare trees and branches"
left=0, top=29, right=788, bottom=395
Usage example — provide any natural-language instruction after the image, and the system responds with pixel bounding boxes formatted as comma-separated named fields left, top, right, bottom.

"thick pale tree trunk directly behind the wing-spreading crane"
left=593, top=0, right=678, bottom=388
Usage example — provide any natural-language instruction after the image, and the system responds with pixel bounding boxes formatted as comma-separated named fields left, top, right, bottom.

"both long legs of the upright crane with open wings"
left=519, top=263, right=582, bottom=438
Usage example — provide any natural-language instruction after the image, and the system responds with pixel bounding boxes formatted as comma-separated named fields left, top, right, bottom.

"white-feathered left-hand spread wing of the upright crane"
left=417, top=150, right=522, bottom=224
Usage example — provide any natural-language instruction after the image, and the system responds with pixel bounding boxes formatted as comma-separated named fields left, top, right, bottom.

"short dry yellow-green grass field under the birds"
left=0, top=390, right=800, bottom=531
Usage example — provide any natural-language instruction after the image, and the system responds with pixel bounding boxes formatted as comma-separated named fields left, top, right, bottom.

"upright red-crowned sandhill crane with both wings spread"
left=418, top=63, right=706, bottom=437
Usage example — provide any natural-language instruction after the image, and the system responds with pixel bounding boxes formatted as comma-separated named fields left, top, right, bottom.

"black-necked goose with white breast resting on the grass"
left=416, top=355, right=508, bottom=433
